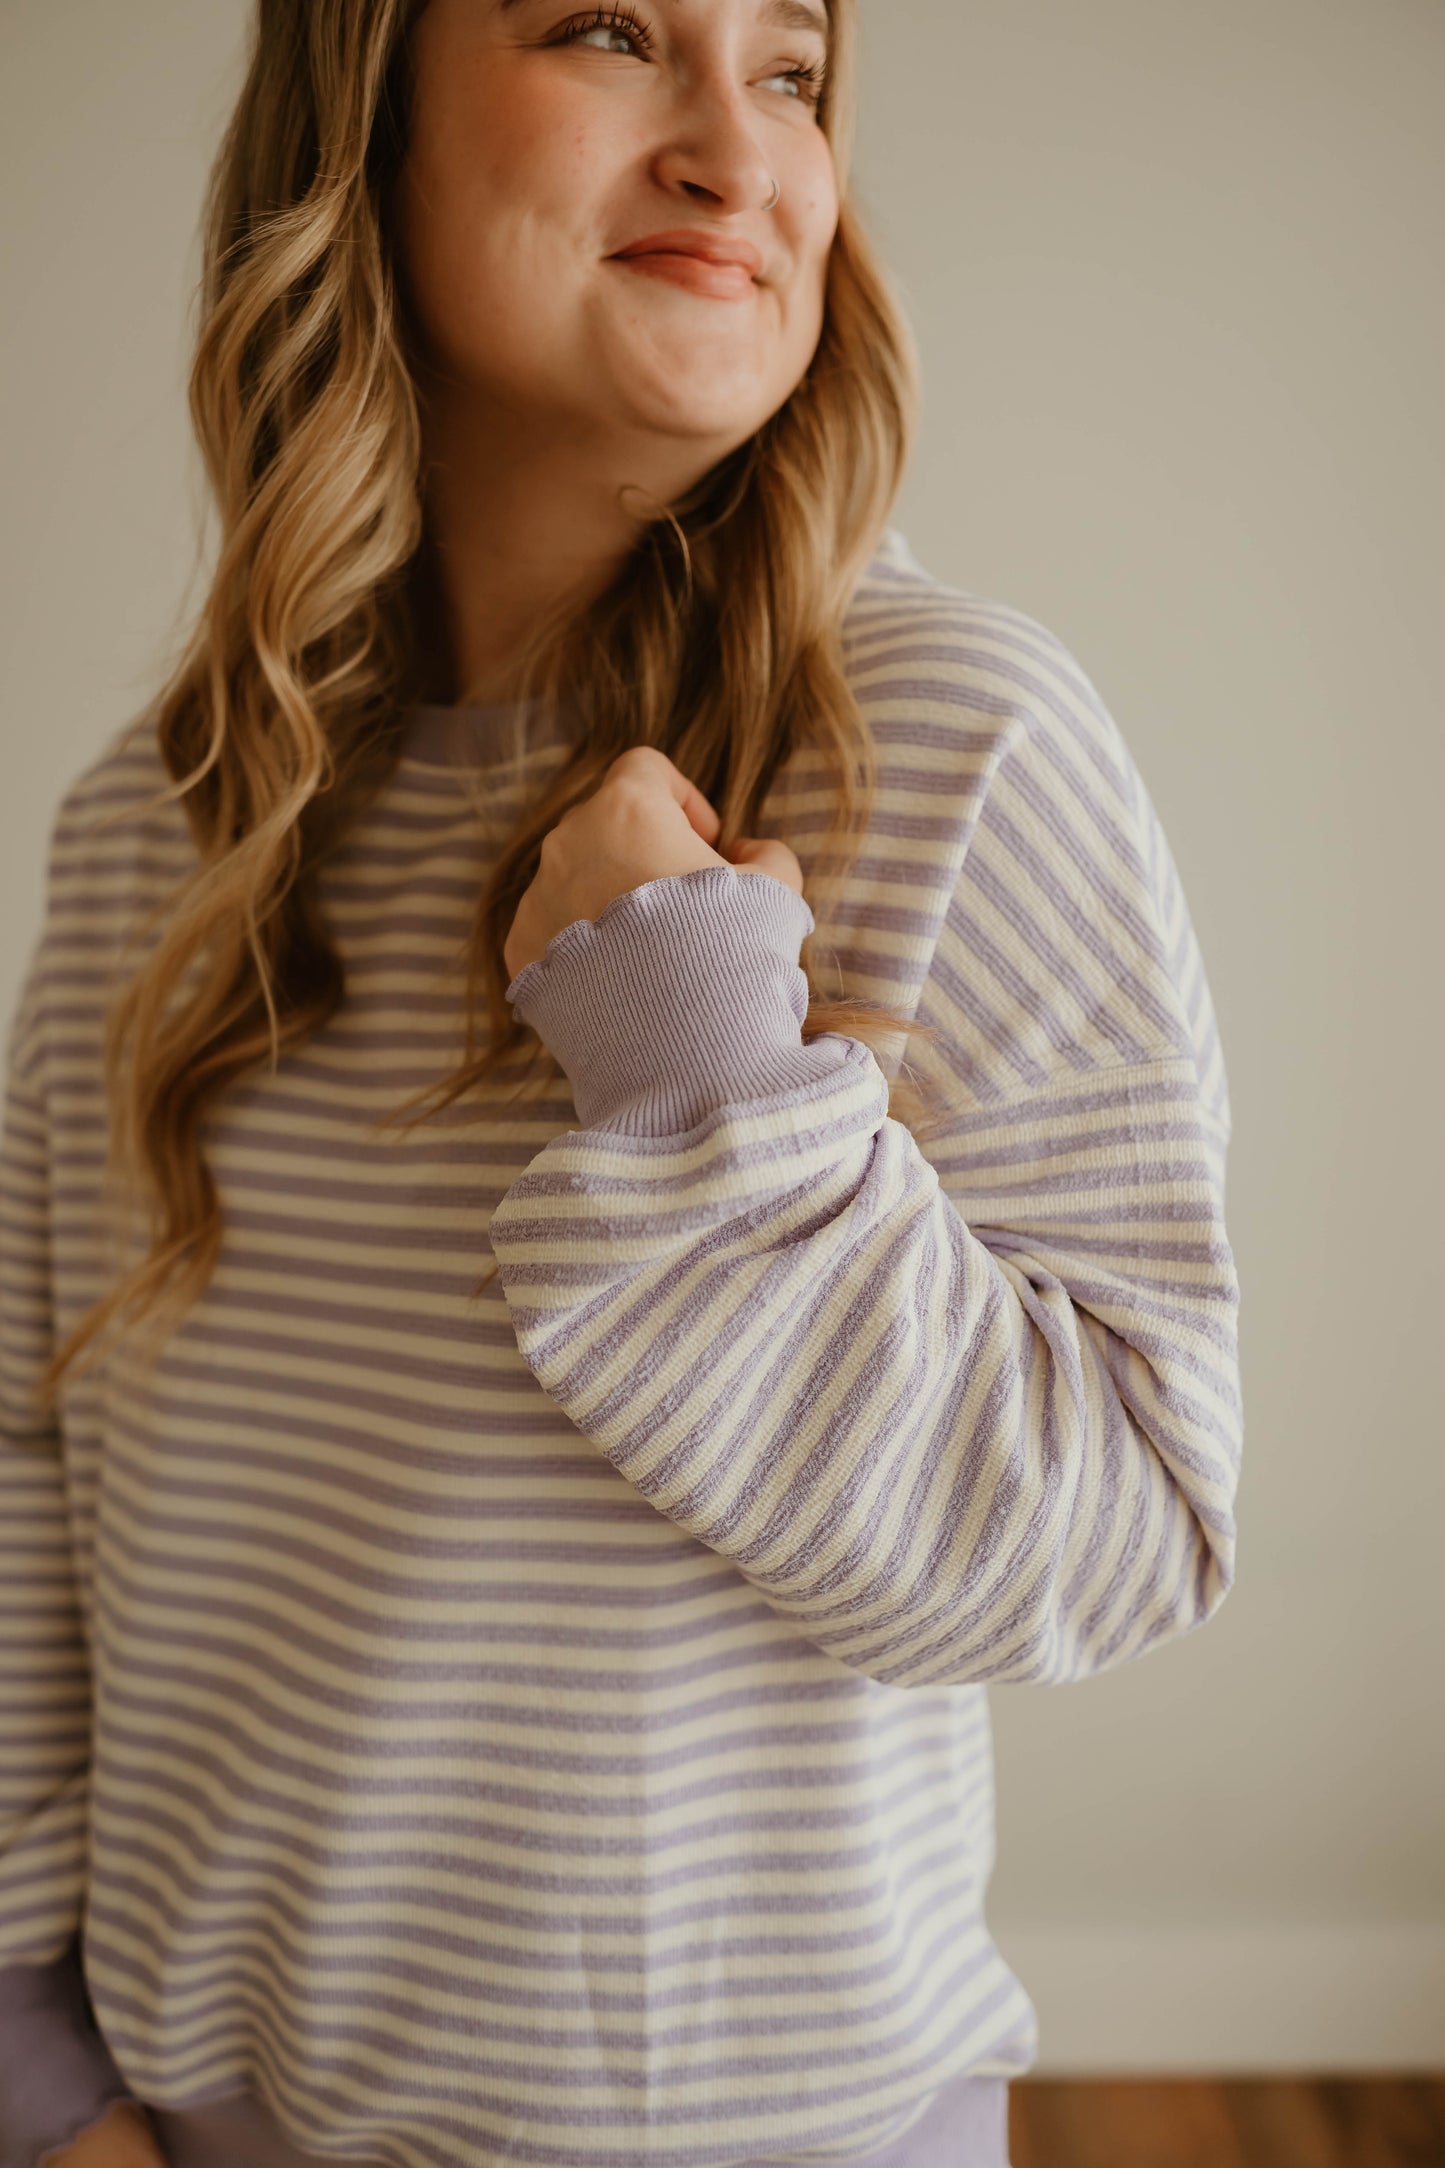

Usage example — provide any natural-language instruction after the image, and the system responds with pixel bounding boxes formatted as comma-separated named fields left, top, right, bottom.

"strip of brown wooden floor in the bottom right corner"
left=1010, top=2073, right=1445, bottom=2168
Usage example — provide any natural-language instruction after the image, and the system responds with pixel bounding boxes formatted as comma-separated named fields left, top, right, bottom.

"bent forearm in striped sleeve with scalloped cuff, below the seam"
left=492, top=874, right=1239, bottom=1687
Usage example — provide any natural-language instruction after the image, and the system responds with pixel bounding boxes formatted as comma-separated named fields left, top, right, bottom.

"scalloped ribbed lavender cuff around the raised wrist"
left=507, top=865, right=847, bottom=1136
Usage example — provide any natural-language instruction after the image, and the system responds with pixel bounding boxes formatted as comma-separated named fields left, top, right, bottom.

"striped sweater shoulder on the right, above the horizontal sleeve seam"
left=847, top=531, right=1231, bottom=1149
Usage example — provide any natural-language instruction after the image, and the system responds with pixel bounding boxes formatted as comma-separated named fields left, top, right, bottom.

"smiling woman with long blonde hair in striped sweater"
left=0, top=0, right=1241, bottom=2168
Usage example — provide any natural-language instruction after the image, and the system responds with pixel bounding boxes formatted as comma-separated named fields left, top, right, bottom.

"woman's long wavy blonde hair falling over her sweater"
left=41, top=0, right=932, bottom=1403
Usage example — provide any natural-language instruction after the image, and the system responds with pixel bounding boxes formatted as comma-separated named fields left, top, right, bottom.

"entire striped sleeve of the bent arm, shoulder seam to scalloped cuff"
left=490, top=650, right=1241, bottom=1687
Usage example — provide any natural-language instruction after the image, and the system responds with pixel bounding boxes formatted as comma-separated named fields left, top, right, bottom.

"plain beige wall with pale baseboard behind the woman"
left=0, top=0, right=1445, bottom=2073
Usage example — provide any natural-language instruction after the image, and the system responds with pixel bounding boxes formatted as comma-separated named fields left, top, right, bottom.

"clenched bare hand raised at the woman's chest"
left=503, top=746, right=804, bottom=978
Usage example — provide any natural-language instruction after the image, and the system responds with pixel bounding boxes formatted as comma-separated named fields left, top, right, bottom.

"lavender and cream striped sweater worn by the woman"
left=0, top=533, right=1241, bottom=2168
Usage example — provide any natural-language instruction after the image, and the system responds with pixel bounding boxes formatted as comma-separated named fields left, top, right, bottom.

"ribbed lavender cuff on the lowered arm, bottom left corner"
left=0, top=1943, right=134, bottom=2168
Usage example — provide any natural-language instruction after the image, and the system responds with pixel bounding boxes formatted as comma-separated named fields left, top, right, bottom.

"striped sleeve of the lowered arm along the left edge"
left=0, top=927, right=130, bottom=2168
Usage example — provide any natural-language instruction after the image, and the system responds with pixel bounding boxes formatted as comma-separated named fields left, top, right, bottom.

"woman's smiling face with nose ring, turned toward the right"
left=399, top=0, right=838, bottom=473
